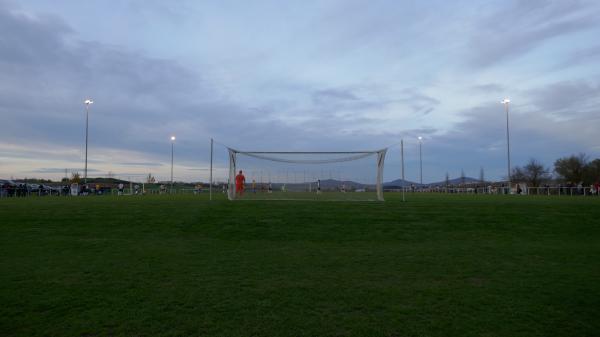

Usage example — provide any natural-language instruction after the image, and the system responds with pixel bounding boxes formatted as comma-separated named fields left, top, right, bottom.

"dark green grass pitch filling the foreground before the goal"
left=0, top=193, right=600, bottom=337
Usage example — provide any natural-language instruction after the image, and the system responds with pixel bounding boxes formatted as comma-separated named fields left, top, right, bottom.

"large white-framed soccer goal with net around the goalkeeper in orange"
left=227, top=148, right=387, bottom=201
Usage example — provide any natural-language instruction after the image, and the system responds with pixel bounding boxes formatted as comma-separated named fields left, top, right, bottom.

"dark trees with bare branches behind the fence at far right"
left=511, top=153, right=600, bottom=187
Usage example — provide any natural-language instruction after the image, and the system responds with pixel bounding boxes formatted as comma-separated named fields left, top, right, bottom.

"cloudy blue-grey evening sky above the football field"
left=0, top=0, right=600, bottom=182
